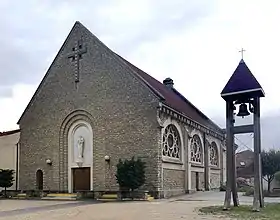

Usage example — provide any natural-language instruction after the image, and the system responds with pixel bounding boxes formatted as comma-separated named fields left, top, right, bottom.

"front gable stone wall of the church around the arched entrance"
left=19, top=23, right=161, bottom=191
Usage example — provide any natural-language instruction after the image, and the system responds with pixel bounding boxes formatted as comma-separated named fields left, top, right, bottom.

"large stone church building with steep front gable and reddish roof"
left=18, top=22, right=225, bottom=197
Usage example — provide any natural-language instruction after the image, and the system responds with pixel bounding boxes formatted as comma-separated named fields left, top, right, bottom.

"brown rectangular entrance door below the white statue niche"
left=73, top=167, right=90, bottom=192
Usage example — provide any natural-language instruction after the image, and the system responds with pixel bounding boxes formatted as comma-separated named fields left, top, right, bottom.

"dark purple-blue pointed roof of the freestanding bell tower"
left=221, top=59, right=265, bottom=100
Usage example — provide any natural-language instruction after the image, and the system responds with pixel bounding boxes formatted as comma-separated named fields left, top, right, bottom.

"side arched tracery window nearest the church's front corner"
left=162, top=124, right=181, bottom=159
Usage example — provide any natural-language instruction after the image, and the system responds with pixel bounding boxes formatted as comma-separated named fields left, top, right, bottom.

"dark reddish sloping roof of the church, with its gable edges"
left=18, top=21, right=223, bottom=134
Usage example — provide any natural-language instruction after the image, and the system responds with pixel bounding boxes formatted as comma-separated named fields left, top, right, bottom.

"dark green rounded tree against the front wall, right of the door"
left=116, top=157, right=146, bottom=191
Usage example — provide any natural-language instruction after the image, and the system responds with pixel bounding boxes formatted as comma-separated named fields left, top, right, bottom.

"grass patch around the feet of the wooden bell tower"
left=199, top=203, right=280, bottom=220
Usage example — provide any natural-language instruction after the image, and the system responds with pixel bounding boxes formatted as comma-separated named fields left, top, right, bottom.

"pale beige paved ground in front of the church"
left=0, top=192, right=280, bottom=220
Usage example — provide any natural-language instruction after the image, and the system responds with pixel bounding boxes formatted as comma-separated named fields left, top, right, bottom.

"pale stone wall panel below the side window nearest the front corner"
left=163, top=169, right=185, bottom=197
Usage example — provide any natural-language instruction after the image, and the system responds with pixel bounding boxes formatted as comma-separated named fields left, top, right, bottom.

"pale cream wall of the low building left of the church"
left=0, top=132, right=20, bottom=191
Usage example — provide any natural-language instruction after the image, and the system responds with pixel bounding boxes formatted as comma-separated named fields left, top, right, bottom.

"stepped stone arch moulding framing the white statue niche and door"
left=59, top=110, right=93, bottom=192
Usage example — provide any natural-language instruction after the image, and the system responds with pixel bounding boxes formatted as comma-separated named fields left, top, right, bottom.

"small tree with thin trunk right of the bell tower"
left=261, top=149, right=280, bottom=192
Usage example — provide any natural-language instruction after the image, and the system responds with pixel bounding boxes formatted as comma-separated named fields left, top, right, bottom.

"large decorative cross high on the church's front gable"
left=68, top=40, right=87, bottom=83
